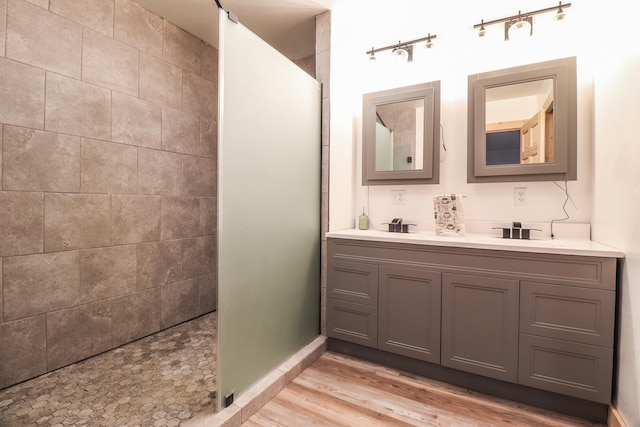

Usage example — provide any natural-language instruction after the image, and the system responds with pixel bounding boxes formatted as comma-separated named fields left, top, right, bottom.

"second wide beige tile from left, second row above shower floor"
left=80, top=245, right=136, bottom=303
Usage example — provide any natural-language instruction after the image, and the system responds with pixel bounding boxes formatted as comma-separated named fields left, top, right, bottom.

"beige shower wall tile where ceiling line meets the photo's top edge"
left=114, top=0, right=163, bottom=58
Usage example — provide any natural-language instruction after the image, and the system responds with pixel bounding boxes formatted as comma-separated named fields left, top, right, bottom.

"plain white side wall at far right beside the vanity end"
left=592, top=1, right=640, bottom=427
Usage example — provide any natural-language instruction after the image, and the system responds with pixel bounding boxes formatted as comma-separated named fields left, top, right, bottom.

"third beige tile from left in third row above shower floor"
left=111, top=195, right=160, bottom=245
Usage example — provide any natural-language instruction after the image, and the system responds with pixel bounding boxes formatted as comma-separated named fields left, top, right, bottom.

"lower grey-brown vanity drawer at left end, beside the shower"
left=327, top=298, right=378, bottom=348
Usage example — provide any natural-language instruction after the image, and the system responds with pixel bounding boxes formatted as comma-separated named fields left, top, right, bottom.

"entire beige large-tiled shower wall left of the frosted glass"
left=0, top=0, right=217, bottom=388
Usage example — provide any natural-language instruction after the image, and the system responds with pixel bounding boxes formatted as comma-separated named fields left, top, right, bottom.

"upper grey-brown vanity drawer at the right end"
left=520, top=282, right=615, bottom=347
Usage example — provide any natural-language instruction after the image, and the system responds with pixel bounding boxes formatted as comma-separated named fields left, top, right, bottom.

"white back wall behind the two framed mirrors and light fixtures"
left=330, top=0, right=592, bottom=234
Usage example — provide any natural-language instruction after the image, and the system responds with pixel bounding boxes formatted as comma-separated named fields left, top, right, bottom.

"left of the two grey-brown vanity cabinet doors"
left=378, top=265, right=441, bottom=363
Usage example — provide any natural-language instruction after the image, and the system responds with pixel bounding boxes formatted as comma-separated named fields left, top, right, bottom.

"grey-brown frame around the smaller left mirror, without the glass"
left=362, top=81, right=440, bottom=185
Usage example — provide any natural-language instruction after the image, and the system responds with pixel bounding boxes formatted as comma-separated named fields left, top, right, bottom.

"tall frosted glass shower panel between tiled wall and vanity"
left=218, top=13, right=321, bottom=406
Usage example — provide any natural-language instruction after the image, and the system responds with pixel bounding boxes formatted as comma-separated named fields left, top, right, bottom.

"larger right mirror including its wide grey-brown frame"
left=467, top=57, right=577, bottom=182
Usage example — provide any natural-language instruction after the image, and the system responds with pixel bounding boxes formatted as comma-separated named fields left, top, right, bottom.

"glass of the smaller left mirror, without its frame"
left=376, top=98, right=424, bottom=171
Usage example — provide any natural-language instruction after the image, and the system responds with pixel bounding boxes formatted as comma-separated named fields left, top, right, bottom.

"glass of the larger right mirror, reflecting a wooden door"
left=485, top=79, right=554, bottom=165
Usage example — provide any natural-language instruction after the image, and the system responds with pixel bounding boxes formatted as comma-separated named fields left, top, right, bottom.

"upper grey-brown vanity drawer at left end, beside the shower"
left=327, top=260, right=378, bottom=307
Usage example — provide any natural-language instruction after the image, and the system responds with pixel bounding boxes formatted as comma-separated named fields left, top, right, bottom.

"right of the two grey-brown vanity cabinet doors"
left=441, top=274, right=519, bottom=383
